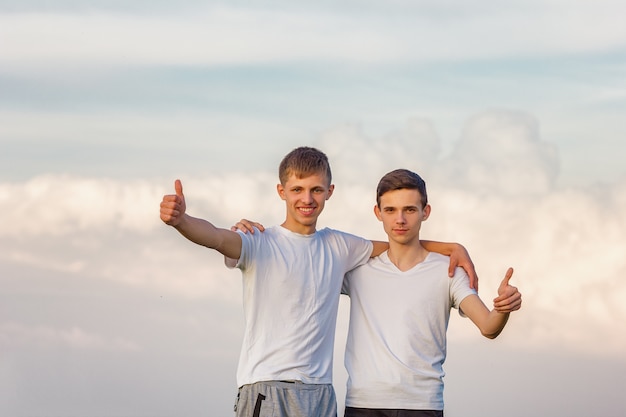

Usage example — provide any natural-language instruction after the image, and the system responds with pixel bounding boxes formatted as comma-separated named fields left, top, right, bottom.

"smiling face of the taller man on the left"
left=276, top=173, right=335, bottom=235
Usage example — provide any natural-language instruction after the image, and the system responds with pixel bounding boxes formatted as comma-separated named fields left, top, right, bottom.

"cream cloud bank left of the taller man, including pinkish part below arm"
left=0, top=173, right=282, bottom=301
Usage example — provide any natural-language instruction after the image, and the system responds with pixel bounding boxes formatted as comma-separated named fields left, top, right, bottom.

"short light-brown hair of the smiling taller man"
left=278, top=146, right=332, bottom=185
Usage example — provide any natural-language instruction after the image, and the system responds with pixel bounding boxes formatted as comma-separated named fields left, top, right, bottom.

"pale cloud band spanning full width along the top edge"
left=0, top=2, right=626, bottom=76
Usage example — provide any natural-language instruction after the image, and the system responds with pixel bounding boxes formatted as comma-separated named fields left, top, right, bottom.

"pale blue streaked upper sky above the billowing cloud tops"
left=0, top=1, right=626, bottom=183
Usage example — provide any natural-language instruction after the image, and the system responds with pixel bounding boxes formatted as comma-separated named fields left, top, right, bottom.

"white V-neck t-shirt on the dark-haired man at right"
left=343, top=252, right=476, bottom=410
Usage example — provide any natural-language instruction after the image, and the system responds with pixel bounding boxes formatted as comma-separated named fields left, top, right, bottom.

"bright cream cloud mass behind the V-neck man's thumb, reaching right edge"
left=438, top=180, right=626, bottom=354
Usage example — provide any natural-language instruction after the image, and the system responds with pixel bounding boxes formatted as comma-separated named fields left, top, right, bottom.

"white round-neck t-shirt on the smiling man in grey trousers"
left=237, top=226, right=372, bottom=386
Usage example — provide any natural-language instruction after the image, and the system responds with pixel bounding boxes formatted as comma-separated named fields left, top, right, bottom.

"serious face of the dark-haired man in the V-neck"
left=374, top=189, right=430, bottom=245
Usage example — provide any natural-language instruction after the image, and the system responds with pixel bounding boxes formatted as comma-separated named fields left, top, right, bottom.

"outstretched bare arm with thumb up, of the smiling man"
left=161, top=180, right=241, bottom=259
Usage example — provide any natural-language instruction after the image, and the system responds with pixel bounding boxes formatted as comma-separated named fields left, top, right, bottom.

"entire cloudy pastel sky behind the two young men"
left=0, top=0, right=626, bottom=417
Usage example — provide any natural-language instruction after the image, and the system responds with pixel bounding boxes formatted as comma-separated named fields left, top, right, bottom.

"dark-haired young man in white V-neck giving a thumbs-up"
left=343, top=169, right=522, bottom=417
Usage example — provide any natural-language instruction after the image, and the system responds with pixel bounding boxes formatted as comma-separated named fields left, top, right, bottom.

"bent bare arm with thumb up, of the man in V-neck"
left=460, top=268, right=522, bottom=339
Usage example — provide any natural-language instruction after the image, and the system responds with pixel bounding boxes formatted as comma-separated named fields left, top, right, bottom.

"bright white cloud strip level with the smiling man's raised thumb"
left=0, top=172, right=280, bottom=237
